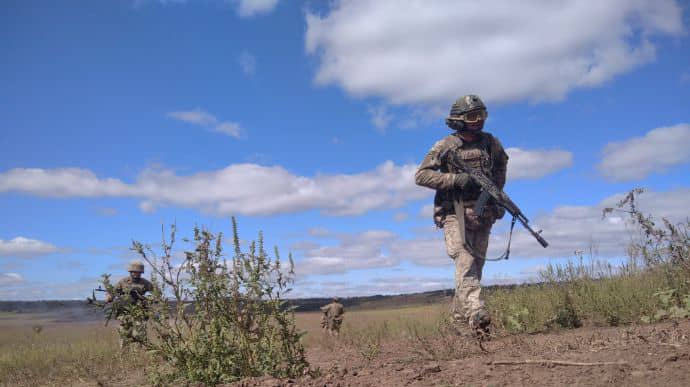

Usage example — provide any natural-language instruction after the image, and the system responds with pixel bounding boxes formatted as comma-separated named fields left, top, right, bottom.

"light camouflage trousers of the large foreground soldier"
left=443, top=215, right=491, bottom=323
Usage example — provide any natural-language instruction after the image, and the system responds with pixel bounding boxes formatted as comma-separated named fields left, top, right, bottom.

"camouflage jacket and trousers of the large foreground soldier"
left=415, top=132, right=508, bottom=328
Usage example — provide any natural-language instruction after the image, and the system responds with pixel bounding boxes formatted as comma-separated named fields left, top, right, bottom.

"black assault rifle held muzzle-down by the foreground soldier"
left=445, top=151, right=549, bottom=248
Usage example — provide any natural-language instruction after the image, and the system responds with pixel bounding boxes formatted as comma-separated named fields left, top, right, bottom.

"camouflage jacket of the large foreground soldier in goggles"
left=415, top=132, right=508, bottom=227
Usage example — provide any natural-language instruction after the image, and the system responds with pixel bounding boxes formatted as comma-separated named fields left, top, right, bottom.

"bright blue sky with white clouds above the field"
left=0, top=0, right=690, bottom=299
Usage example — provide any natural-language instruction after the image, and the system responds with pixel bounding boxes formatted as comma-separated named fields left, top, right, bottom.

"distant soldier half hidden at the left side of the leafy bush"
left=105, top=260, right=153, bottom=348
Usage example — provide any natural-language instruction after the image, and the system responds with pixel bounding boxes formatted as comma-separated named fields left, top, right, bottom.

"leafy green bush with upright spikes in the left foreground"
left=91, top=218, right=308, bottom=385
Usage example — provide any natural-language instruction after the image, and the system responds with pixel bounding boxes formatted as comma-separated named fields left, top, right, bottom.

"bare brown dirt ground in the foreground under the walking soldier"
left=237, top=320, right=690, bottom=386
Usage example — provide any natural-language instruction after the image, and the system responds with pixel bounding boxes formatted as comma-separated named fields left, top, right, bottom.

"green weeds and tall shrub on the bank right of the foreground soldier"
left=487, top=189, right=690, bottom=332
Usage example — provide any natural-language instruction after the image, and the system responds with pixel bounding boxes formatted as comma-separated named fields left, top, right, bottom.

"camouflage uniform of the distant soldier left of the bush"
left=113, top=277, right=153, bottom=348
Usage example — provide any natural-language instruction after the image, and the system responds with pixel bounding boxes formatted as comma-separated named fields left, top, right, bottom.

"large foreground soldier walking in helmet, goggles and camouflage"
left=415, top=95, right=508, bottom=335
